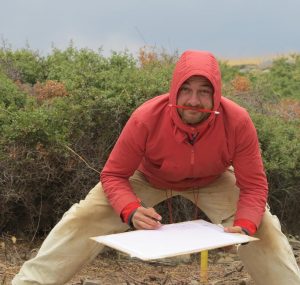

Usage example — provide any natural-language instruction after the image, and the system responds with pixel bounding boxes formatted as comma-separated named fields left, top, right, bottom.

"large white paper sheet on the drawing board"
left=92, top=220, right=257, bottom=260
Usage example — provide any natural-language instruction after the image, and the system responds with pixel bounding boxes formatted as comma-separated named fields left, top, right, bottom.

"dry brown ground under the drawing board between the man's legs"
left=68, top=252, right=254, bottom=285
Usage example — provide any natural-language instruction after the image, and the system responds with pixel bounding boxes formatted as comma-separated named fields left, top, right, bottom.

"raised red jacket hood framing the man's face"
left=169, top=50, right=221, bottom=132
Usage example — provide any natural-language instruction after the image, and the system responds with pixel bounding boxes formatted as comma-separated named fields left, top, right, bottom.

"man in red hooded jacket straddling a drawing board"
left=13, top=51, right=300, bottom=285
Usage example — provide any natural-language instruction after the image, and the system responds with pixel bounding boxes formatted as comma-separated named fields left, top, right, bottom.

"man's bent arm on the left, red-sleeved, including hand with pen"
left=101, top=112, right=161, bottom=229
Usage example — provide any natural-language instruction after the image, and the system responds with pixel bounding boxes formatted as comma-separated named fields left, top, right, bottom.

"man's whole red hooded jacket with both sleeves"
left=101, top=48, right=268, bottom=227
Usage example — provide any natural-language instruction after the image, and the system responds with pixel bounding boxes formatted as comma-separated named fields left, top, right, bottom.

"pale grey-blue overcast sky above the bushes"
left=0, top=0, right=300, bottom=58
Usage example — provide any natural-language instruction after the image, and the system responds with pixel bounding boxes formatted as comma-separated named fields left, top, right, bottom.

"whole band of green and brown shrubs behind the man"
left=0, top=45, right=300, bottom=236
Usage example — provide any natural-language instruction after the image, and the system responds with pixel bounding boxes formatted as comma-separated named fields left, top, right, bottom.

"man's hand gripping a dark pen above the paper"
left=132, top=207, right=162, bottom=230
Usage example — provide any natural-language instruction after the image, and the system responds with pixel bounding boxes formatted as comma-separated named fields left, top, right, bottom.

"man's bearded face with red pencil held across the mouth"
left=177, top=76, right=214, bottom=125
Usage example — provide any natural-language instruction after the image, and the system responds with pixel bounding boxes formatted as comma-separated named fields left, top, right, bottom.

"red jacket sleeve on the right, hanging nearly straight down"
left=233, top=114, right=268, bottom=228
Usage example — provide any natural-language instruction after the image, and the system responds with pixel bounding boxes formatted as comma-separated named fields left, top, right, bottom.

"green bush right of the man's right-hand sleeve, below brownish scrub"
left=252, top=114, right=300, bottom=233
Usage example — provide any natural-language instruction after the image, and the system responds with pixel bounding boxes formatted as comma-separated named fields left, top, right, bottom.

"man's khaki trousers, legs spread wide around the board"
left=12, top=171, right=300, bottom=285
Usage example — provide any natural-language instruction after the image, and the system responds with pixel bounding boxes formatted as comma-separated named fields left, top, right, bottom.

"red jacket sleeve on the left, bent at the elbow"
left=100, top=112, right=147, bottom=215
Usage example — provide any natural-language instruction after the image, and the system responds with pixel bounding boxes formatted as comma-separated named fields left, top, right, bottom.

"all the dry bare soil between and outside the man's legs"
left=0, top=237, right=300, bottom=285
